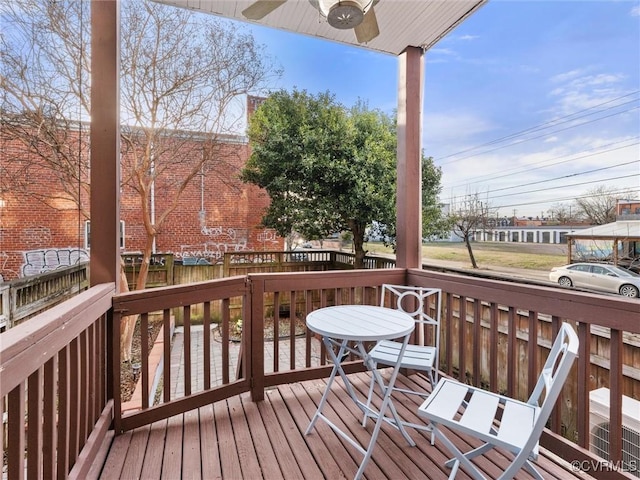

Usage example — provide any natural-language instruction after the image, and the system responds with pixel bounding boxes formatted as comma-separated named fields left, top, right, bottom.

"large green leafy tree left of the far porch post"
left=242, top=90, right=396, bottom=268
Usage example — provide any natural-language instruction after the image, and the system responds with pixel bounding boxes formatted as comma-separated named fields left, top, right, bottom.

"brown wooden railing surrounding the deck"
left=0, top=269, right=640, bottom=478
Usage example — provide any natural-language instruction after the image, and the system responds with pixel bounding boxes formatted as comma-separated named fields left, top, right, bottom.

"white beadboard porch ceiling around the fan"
left=153, top=0, right=488, bottom=55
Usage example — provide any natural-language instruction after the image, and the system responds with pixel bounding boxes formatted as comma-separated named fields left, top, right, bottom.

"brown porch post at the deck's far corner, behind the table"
left=396, top=47, right=424, bottom=268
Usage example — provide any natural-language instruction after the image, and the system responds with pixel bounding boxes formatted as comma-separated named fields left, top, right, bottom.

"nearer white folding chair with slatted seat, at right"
left=418, top=323, right=579, bottom=480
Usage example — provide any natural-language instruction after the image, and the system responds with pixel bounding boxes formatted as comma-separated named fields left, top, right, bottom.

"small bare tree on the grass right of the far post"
left=449, top=193, right=495, bottom=268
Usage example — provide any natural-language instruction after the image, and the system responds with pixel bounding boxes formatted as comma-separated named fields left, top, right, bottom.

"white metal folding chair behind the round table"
left=362, top=284, right=442, bottom=430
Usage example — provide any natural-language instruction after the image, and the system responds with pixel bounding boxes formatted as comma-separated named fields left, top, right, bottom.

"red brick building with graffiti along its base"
left=0, top=98, right=284, bottom=281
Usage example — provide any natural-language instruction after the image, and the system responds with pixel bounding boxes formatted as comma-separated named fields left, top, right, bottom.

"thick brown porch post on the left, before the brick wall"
left=89, top=0, right=120, bottom=291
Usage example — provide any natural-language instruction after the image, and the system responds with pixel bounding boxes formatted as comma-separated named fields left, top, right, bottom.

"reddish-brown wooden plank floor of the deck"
left=100, top=374, right=585, bottom=480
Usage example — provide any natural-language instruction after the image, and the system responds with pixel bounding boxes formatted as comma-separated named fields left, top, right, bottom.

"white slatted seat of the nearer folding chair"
left=418, top=378, right=540, bottom=455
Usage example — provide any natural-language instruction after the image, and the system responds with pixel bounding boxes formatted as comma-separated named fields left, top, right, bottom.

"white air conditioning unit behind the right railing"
left=589, top=388, right=640, bottom=478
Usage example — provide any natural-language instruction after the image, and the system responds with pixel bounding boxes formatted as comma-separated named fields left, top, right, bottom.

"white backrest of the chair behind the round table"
left=380, top=283, right=442, bottom=348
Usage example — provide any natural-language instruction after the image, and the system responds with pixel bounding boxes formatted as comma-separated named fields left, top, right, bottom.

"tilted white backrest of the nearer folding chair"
left=527, top=322, right=580, bottom=450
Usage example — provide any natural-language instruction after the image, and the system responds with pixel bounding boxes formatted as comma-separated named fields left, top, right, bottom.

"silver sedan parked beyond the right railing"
left=549, top=263, right=640, bottom=298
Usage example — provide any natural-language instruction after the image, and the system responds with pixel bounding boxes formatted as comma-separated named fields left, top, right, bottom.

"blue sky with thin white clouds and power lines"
left=241, top=0, right=640, bottom=217
